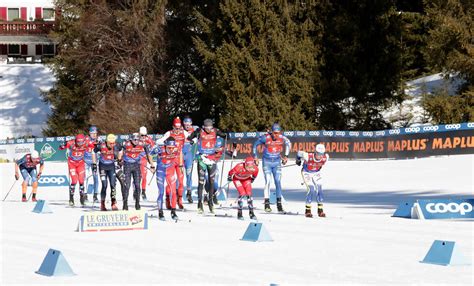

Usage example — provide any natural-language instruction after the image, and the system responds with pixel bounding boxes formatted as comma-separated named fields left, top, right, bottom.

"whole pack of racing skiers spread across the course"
left=15, top=117, right=329, bottom=220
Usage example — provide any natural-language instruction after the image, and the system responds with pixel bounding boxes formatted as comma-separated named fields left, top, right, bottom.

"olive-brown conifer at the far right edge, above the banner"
left=423, top=0, right=474, bottom=124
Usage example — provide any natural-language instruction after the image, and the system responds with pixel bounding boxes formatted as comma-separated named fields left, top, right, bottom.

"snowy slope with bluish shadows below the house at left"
left=0, top=64, right=55, bottom=139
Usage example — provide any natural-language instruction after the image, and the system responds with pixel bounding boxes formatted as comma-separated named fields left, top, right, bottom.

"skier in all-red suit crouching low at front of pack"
left=227, top=157, right=258, bottom=219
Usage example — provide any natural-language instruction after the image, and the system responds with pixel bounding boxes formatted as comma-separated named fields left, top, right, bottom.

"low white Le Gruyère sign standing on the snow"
left=77, top=210, right=148, bottom=232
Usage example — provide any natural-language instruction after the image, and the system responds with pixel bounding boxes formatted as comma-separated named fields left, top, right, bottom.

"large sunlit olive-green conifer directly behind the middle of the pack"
left=195, top=0, right=318, bottom=131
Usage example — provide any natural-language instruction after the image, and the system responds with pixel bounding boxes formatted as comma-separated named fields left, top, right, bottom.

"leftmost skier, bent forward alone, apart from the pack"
left=15, top=150, right=44, bottom=202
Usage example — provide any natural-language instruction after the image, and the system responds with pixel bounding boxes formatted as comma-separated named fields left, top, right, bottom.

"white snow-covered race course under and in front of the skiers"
left=0, top=155, right=474, bottom=285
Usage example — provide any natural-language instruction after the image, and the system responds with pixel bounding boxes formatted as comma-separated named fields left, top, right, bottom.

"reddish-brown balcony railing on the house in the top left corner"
left=0, top=21, right=56, bottom=35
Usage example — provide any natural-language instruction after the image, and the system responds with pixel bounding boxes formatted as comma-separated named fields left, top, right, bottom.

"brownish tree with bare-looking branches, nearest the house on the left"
left=44, top=0, right=167, bottom=135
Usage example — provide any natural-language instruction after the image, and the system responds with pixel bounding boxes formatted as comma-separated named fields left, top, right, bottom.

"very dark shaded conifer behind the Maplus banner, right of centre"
left=316, top=0, right=402, bottom=130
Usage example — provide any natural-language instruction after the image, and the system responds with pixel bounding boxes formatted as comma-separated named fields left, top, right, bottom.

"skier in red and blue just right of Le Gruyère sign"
left=152, top=137, right=180, bottom=220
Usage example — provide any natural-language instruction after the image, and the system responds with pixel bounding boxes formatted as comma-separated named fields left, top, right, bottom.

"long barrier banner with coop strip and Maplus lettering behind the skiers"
left=0, top=122, right=474, bottom=162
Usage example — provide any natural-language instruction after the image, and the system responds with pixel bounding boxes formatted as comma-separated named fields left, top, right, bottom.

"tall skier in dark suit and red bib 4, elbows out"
left=188, top=119, right=227, bottom=213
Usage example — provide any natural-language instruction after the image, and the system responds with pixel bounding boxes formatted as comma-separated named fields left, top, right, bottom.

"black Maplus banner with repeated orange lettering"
left=227, top=130, right=474, bottom=159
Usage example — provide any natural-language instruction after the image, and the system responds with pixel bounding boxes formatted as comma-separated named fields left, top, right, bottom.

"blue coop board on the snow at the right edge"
left=418, top=199, right=474, bottom=219
